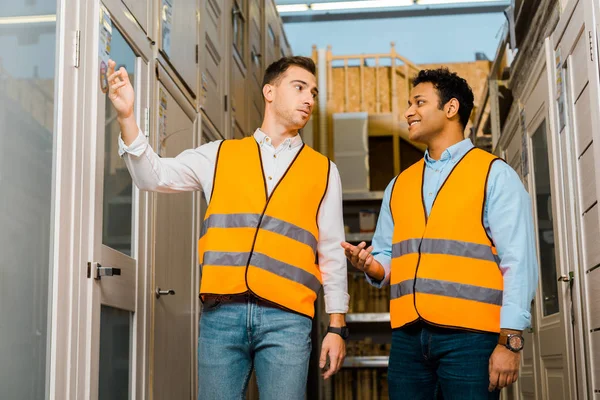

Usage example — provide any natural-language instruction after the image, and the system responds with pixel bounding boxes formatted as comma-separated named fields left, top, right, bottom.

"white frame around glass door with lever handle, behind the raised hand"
left=74, top=0, right=153, bottom=400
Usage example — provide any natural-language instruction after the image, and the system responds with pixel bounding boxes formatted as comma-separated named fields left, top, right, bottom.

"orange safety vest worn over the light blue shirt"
left=390, top=148, right=504, bottom=332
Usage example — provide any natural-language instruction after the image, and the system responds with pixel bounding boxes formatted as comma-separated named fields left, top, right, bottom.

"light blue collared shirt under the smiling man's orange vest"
left=367, top=139, right=538, bottom=330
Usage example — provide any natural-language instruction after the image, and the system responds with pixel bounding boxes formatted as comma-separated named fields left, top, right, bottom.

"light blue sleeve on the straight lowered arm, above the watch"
left=484, top=161, right=538, bottom=330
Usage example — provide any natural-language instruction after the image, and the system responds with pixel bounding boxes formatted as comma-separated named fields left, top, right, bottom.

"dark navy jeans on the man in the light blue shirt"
left=388, top=322, right=500, bottom=400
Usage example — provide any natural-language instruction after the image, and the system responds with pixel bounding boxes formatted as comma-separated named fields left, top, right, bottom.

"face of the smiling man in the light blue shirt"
left=404, top=82, right=448, bottom=143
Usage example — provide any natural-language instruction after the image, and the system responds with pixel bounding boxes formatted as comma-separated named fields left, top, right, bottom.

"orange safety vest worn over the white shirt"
left=198, top=137, right=329, bottom=318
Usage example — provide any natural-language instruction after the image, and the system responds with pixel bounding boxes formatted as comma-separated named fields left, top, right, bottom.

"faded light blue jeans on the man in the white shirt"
left=198, top=296, right=312, bottom=400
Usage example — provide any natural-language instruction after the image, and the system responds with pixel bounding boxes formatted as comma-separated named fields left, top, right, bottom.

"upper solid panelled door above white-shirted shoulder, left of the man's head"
left=199, top=0, right=228, bottom=135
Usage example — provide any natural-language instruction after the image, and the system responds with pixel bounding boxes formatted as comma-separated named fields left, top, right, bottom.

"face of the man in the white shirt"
left=270, top=65, right=319, bottom=129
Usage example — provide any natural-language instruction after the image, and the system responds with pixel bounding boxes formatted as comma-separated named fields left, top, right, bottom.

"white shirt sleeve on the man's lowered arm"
left=317, top=161, right=350, bottom=314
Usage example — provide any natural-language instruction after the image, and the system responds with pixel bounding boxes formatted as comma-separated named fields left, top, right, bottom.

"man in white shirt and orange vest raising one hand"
left=108, top=57, right=349, bottom=400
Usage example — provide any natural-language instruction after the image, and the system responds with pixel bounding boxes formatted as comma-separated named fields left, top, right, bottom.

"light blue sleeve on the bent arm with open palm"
left=365, top=178, right=396, bottom=288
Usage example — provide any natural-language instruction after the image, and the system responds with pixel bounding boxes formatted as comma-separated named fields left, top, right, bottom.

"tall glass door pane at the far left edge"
left=0, top=1, right=57, bottom=399
